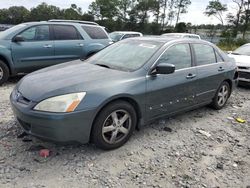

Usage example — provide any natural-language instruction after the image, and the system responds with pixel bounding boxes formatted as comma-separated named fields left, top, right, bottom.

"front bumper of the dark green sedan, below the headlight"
left=10, top=92, right=95, bottom=143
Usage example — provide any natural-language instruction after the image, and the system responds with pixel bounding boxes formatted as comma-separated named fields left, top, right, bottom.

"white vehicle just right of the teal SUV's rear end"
left=109, top=31, right=143, bottom=42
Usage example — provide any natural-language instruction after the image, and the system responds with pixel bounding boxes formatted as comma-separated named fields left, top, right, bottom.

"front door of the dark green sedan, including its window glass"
left=146, top=44, right=197, bottom=120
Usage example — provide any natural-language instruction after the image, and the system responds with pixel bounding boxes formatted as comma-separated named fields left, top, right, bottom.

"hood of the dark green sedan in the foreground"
left=17, top=60, right=131, bottom=102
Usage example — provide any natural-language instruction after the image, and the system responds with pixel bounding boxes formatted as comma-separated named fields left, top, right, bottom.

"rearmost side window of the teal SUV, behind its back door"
left=82, top=25, right=108, bottom=39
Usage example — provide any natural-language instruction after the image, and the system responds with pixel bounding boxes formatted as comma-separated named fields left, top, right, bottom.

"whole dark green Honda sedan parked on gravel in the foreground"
left=10, top=37, right=237, bottom=149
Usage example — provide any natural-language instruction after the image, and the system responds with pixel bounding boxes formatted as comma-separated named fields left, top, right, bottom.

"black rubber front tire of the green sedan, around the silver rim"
left=91, top=101, right=137, bottom=150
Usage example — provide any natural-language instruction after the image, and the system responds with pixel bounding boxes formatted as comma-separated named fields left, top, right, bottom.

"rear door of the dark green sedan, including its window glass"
left=192, top=43, right=226, bottom=103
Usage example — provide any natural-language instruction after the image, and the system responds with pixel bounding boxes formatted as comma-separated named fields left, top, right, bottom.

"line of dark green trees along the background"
left=0, top=0, right=250, bottom=37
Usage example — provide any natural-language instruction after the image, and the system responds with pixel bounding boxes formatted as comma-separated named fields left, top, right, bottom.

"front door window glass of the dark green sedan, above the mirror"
left=159, top=44, right=192, bottom=70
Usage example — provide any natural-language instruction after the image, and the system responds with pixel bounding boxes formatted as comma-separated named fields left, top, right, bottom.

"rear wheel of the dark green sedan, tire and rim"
left=211, top=81, right=231, bottom=110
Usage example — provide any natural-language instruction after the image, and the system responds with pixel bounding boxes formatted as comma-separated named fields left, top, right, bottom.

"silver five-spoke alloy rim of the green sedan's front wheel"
left=102, top=110, right=132, bottom=144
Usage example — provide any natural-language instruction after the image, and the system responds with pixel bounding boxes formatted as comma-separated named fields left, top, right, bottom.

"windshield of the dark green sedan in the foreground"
left=87, top=40, right=163, bottom=71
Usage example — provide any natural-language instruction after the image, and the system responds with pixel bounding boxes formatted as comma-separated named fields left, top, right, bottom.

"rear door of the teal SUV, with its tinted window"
left=52, top=24, right=85, bottom=64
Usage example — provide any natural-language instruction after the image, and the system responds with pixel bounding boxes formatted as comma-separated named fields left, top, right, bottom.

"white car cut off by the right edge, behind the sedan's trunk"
left=229, top=43, right=250, bottom=84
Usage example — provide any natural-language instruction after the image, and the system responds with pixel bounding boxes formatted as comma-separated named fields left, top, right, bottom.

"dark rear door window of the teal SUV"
left=53, top=25, right=82, bottom=40
